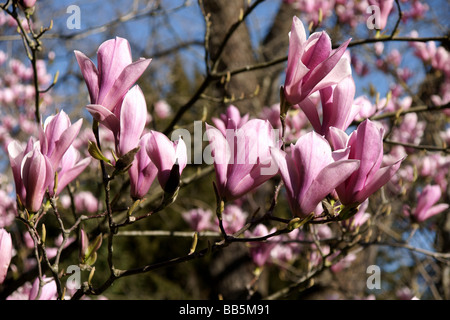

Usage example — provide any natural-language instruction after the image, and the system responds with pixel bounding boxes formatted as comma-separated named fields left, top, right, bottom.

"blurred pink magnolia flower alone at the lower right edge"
left=404, top=185, right=449, bottom=223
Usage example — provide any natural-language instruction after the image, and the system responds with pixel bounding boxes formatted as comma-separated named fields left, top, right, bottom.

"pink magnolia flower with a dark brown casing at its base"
left=146, top=130, right=187, bottom=190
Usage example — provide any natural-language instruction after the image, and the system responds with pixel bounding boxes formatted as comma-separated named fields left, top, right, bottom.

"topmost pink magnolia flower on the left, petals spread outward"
left=75, top=37, right=151, bottom=111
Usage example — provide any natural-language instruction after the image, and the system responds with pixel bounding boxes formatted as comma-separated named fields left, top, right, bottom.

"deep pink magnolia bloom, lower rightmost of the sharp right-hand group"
left=330, top=120, right=403, bottom=205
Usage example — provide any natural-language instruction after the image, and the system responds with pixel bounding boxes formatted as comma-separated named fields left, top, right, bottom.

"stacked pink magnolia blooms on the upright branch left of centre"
left=75, top=37, right=187, bottom=199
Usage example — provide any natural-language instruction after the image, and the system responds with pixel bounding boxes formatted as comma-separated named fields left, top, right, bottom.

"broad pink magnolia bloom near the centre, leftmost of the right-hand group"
left=206, top=119, right=279, bottom=201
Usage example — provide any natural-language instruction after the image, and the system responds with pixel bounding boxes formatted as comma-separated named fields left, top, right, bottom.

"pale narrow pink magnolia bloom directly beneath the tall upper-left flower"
left=86, top=85, right=147, bottom=156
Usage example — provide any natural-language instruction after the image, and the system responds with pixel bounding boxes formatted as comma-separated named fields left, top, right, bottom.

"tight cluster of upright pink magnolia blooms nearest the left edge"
left=8, top=111, right=90, bottom=212
